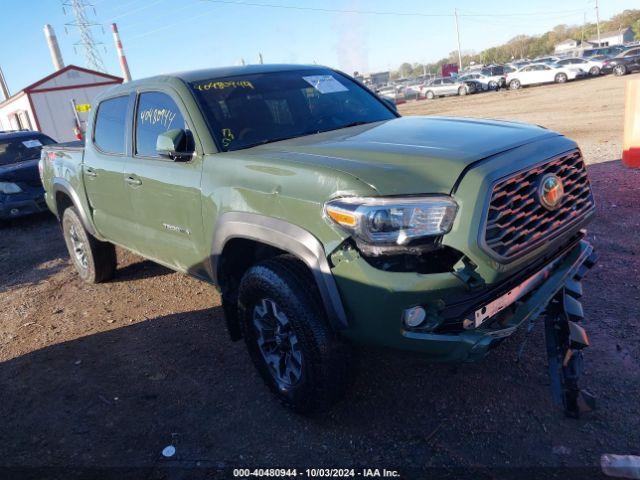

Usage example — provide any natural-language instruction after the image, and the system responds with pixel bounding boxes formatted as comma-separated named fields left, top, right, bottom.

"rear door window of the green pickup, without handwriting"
left=93, top=96, right=129, bottom=155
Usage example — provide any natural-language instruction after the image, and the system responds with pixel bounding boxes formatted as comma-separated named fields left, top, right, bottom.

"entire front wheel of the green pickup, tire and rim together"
left=238, top=255, right=350, bottom=413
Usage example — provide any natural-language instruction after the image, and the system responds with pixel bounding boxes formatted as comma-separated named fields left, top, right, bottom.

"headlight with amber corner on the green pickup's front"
left=325, top=195, right=458, bottom=245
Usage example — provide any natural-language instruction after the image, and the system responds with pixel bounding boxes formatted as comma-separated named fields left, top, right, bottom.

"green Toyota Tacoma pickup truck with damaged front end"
left=40, top=65, right=595, bottom=416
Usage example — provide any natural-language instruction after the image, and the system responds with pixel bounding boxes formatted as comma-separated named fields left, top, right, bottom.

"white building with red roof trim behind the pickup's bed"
left=0, top=65, right=122, bottom=142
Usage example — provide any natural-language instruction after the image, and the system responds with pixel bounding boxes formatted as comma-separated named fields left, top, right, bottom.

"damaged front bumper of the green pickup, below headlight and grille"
left=334, top=240, right=594, bottom=362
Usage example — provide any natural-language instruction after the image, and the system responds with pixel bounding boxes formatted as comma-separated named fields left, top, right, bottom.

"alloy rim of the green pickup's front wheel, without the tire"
left=253, top=298, right=303, bottom=389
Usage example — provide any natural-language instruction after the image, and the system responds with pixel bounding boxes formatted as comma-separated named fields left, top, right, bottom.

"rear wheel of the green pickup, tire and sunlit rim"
left=62, top=207, right=117, bottom=283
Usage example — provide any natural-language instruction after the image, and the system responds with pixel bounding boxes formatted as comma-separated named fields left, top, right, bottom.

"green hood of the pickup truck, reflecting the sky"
left=250, top=116, right=559, bottom=195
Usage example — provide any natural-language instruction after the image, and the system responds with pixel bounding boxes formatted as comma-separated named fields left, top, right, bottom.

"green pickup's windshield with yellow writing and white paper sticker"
left=190, top=69, right=395, bottom=151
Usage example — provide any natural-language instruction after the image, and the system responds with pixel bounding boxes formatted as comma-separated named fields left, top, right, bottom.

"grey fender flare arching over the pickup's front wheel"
left=210, top=212, right=348, bottom=330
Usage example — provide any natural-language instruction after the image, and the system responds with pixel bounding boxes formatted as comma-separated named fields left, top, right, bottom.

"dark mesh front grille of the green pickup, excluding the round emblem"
left=483, top=150, right=594, bottom=261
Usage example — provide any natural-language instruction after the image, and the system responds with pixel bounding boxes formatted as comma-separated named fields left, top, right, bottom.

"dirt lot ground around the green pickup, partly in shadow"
left=0, top=73, right=640, bottom=479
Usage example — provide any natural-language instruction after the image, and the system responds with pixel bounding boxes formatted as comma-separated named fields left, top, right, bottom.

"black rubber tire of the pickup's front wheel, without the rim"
left=238, top=255, right=351, bottom=413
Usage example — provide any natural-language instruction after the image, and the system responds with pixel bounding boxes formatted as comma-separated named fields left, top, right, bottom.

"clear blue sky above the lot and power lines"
left=0, top=0, right=640, bottom=93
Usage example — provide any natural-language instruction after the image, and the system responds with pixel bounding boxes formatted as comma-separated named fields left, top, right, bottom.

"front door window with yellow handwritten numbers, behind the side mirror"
left=135, top=92, right=192, bottom=157
